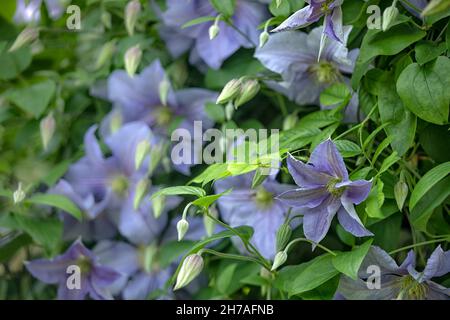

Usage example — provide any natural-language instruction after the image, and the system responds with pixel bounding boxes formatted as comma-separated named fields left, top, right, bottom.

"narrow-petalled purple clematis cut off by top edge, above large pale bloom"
left=272, top=0, right=345, bottom=44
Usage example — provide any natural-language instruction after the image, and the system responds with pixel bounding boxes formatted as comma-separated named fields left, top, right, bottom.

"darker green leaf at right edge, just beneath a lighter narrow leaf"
left=409, top=176, right=450, bottom=232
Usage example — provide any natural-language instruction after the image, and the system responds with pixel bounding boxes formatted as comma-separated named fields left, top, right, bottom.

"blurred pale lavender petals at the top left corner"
left=14, top=0, right=67, bottom=24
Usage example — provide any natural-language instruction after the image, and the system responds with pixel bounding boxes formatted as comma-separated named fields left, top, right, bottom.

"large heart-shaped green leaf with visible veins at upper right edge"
left=397, top=57, right=450, bottom=124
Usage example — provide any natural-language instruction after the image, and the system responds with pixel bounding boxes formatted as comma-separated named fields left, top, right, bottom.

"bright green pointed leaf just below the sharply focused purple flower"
left=332, top=239, right=373, bottom=280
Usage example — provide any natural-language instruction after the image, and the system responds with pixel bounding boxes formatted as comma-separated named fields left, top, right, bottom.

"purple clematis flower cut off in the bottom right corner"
left=338, top=246, right=450, bottom=300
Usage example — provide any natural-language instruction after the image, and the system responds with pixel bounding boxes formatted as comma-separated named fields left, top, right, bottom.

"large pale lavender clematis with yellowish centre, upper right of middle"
left=255, top=26, right=359, bottom=122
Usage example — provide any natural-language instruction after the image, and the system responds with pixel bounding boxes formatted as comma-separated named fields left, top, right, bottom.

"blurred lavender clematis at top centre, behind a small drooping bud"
left=160, top=0, right=267, bottom=69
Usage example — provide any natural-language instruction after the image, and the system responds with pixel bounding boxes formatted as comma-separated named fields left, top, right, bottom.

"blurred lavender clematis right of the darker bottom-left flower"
left=94, top=216, right=211, bottom=300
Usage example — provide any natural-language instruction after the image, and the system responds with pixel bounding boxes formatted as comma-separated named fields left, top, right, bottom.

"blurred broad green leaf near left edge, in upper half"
left=5, top=80, right=56, bottom=118
